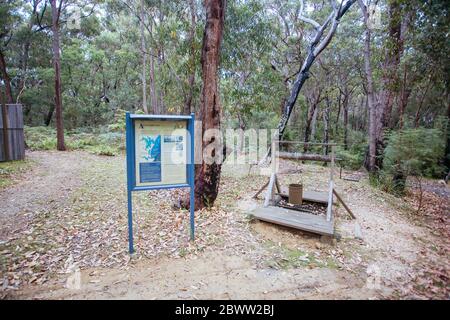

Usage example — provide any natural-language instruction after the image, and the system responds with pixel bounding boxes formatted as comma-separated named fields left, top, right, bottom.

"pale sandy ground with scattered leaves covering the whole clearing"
left=0, top=152, right=448, bottom=299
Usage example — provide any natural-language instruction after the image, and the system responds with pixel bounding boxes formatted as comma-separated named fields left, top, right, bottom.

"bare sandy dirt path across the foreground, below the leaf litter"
left=21, top=252, right=378, bottom=300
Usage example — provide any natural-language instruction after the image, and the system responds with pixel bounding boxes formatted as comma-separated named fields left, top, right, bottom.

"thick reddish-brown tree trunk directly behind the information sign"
left=195, top=0, right=226, bottom=209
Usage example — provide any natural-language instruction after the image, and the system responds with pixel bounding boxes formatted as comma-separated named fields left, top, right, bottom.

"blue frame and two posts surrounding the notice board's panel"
left=125, top=112, right=195, bottom=254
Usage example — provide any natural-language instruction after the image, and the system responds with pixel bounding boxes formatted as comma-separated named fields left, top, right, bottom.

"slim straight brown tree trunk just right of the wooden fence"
left=51, top=0, right=66, bottom=151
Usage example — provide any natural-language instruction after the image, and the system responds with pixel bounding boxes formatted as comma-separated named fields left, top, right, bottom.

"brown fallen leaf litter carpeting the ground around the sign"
left=0, top=154, right=450, bottom=298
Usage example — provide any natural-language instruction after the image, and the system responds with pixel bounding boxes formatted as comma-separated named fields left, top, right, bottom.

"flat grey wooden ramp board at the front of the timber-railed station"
left=250, top=206, right=334, bottom=236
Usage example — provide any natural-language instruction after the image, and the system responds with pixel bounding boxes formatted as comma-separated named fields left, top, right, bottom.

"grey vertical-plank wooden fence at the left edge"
left=0, top=104, right=25, bottom=161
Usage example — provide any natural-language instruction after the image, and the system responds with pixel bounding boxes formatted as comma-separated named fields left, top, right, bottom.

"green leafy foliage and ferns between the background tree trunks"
left=0, top=0, right=450, bottom=190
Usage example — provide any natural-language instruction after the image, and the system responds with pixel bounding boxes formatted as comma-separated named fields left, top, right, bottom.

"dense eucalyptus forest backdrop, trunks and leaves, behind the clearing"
left=0, top=0, right=450, bottom=194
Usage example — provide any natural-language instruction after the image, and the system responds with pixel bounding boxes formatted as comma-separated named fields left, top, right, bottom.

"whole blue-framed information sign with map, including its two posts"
left=126, top=113, right=195, bottom=253
